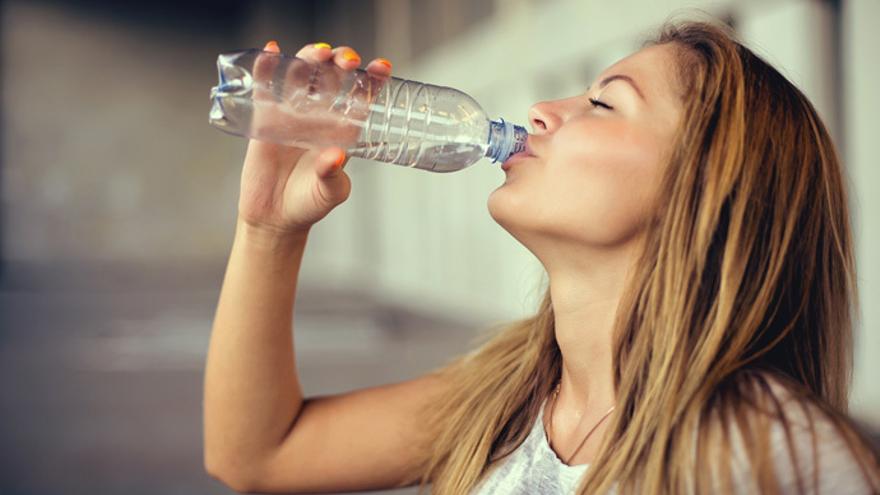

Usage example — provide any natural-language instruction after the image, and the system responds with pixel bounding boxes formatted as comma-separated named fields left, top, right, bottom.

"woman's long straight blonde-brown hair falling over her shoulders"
left=406, top=17, right=880, bottom=495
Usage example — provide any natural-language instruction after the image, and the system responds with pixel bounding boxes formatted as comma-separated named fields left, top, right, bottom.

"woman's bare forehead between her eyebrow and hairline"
left=596, top=45, right=678, bottom=104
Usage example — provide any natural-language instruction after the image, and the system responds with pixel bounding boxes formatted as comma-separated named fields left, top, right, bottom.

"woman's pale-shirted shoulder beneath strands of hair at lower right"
left=731, top=374, right=873, bottom=494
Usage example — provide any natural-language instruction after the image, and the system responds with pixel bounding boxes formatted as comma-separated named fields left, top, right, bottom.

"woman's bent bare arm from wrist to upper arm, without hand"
left=204, top=221, right=447, bottom=493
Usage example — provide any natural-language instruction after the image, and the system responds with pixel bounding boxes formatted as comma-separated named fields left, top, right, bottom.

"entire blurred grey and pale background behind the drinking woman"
left=0, top=0, right=880, bottom=495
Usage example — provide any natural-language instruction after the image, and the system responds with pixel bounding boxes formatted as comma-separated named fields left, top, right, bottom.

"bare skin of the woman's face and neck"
left=488, top=45, right=682, bottom=465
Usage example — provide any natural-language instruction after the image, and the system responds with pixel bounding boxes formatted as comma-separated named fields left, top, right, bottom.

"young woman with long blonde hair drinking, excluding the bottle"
left=204, top=17, right=880, bottom=495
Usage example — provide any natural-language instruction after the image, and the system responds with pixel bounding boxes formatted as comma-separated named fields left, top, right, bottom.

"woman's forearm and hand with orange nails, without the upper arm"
left=204, top=44, right=391, bottom=491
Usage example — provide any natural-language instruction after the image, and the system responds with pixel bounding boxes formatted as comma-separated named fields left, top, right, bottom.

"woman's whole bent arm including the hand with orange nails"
left=203, top=43, right=422, bottom=491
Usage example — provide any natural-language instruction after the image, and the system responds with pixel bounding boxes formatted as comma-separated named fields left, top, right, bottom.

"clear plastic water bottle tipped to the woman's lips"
left=209, top=48, right=528, bottom=172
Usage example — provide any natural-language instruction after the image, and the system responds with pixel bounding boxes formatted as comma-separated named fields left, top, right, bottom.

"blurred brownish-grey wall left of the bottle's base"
left=2, top=2, right=241, bottom=266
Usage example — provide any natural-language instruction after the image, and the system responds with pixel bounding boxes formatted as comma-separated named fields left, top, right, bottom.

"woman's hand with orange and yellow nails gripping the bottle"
left=238, top=41, right=391, bottom=235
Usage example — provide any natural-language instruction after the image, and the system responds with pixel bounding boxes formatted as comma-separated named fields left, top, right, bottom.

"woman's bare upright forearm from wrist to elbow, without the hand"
left=203, top=220, right=307, bottom=471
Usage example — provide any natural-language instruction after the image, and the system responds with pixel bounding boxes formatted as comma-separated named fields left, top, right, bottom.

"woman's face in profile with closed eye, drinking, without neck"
left=488, top=45, right=682, bottom=258
